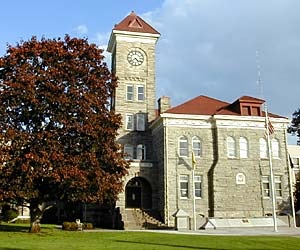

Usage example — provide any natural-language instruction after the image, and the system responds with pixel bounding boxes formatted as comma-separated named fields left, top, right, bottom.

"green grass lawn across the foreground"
left=0, top=224, right=300, bottom=250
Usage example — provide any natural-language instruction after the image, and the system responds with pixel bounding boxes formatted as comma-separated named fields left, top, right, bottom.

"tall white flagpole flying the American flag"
left=265, top=104, right=278, bottom=232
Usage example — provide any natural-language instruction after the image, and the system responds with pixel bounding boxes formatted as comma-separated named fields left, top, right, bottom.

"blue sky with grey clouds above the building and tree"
left=0, top=0, right=300, bottom=141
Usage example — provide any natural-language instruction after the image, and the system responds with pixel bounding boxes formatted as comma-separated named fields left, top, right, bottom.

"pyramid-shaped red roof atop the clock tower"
left=113, top=11, right=159, bottom=35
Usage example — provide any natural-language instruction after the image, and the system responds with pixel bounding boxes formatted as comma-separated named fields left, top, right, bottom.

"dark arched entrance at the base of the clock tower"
left=125, top=177, right=152, bottom=209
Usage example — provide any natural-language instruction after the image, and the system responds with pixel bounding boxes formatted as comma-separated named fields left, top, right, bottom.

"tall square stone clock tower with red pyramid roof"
left=107, top=12, right=160, bottom=212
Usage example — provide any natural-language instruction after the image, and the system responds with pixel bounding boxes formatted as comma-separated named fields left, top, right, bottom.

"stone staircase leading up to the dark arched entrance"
left=123, top=208, right=168, bottom=230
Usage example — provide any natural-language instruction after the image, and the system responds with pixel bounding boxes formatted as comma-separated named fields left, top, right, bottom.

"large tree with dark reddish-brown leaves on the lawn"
left=0, top=35, right=128, bottom=231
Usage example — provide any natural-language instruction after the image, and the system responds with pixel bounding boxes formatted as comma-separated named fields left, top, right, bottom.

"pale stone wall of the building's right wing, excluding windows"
left=164, top=115, right=290, bottom=229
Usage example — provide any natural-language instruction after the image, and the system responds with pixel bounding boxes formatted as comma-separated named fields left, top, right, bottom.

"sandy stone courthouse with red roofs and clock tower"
left=108, top=12, right=290, bottom=228
